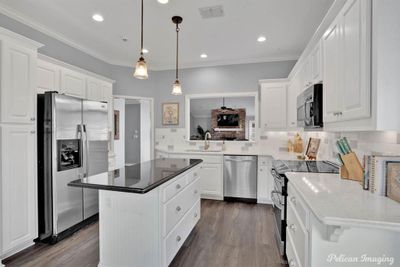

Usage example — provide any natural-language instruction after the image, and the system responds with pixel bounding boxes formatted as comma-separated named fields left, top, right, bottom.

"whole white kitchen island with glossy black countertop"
left=69, top=158, right=202, bottom=267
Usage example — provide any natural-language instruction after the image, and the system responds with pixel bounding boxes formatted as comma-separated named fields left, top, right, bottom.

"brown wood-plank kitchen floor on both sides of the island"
left=3, top=200, right=287, bottom=267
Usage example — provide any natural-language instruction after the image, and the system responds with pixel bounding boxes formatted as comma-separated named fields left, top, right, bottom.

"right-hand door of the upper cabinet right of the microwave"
left=340, top=0, right=371, bottom=120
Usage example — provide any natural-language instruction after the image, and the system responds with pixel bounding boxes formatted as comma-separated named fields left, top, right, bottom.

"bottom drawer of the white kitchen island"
left=164, top=200, right=200, bottom=266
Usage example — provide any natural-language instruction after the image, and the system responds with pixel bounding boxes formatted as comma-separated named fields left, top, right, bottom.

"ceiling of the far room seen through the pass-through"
left=190, top=96, right=256, bottom=118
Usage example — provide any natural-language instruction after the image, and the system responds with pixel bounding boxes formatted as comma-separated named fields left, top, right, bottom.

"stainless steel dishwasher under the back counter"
left=224, top=155, right=257, bottom=202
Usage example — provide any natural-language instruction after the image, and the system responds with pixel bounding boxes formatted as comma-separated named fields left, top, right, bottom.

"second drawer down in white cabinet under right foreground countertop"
left=286, top=203, right=308, bottom=266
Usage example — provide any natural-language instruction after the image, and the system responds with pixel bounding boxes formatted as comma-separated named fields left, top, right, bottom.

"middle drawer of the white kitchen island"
left=163, top=180, right=200, bottom=236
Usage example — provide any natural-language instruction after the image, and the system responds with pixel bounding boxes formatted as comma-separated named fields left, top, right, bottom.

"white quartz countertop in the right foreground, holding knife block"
left=286, top=173, right=400, bottom=231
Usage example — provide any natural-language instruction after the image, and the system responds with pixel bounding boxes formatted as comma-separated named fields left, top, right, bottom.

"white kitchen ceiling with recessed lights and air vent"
left=0, top=0, right=334, bottom=70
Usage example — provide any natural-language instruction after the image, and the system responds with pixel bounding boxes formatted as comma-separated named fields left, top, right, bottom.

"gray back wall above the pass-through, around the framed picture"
left=154, top=60, right=296, bottom=128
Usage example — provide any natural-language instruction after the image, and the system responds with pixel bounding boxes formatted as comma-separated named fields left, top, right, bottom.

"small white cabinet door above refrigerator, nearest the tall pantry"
left=37, top=59, right=61, bottom=94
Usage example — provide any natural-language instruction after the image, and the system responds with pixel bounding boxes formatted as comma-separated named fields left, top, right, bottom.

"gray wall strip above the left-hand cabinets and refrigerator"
left=0, top=14, right=112, bottom=78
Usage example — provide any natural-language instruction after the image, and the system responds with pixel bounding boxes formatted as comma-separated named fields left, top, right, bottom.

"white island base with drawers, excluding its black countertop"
left=98, top=163, right=202, bottom=267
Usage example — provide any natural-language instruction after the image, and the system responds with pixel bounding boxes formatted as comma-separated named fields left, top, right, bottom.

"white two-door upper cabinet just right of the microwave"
left=323, top=0, right=371, bottom=122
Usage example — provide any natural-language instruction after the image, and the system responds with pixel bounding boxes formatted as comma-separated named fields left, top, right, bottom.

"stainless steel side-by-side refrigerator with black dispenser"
left=38, top=92, right=108, bottom=242
